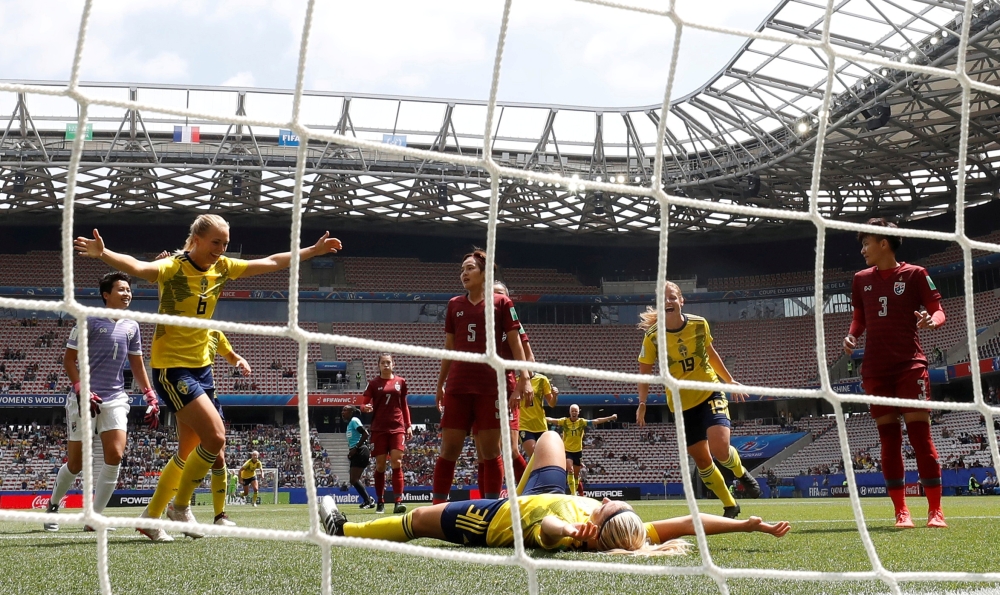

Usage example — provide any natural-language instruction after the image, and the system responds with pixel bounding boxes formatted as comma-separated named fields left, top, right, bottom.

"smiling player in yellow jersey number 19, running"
left=635, top=281, right=760, bottom=519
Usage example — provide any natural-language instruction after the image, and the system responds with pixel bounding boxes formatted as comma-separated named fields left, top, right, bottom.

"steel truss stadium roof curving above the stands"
left=0, top=0, right=1000, bottom=243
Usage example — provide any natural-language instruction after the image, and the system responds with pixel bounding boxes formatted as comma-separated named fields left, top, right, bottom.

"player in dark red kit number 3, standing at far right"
left=844, top=218, right=948, bottom=529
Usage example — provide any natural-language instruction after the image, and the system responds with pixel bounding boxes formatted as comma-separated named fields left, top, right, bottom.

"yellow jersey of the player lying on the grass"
left=486, top=494, right=601, bottom=550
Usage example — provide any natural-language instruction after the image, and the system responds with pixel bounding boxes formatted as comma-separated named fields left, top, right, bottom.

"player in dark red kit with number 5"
left=432, top=250, right=531, bottom=503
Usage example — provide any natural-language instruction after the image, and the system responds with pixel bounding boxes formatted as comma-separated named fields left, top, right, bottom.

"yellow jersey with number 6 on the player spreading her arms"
left=150, top=253, right=249, bottom=369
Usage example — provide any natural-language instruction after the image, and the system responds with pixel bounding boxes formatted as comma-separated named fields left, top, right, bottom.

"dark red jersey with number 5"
left=444, top=293, right=521, bottom=395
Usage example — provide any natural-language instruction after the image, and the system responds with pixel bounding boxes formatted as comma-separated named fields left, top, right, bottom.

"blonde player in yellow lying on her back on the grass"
left=319, top=432, right=790, bottom=555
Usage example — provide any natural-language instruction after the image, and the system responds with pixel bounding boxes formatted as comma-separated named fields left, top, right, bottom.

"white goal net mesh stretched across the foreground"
left=0, top=0, right=1000, bottom=595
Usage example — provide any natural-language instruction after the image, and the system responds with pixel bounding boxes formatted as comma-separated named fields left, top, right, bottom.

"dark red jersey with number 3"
left=851, top=262, right=941, bottom=377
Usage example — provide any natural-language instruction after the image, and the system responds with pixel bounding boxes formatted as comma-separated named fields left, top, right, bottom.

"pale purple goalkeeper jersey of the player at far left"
left=66, top=318, right=142, bottom=401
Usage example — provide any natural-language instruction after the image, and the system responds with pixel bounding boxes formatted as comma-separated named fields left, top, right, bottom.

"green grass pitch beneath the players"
left=0, top=497, right=1000, bottom=595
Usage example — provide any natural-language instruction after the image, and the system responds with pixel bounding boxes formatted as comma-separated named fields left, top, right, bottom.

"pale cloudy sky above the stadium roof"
left=0, top=0, right=774, bottom=106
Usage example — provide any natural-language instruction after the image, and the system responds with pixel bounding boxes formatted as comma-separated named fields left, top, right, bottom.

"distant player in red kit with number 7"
left=361, top=353, right=413, bottom=514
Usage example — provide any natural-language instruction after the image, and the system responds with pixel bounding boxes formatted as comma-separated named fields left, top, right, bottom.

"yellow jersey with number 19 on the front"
left=640, top=314, right=719, bottom=414
